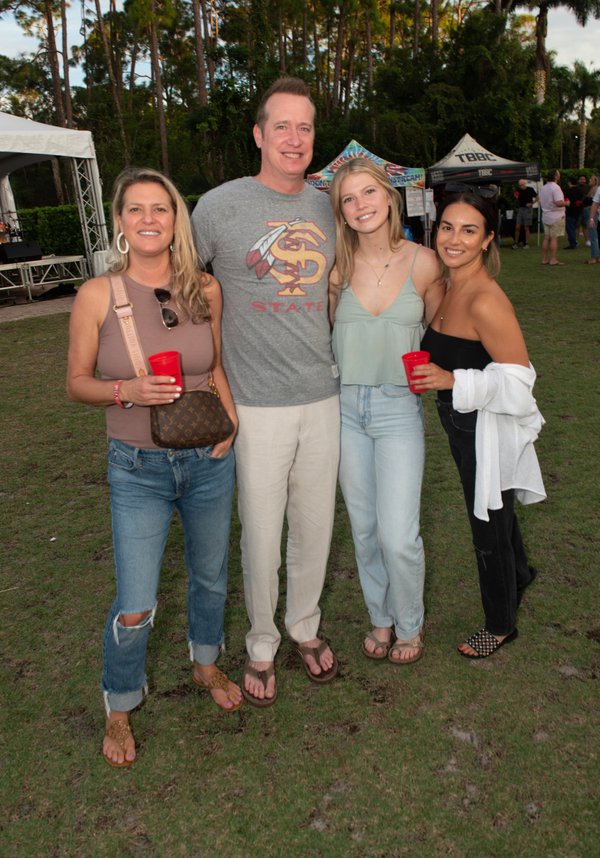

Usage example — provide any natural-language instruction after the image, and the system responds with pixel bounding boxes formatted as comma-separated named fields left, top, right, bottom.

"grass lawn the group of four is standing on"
left=0, top=241, right=600, bottom=858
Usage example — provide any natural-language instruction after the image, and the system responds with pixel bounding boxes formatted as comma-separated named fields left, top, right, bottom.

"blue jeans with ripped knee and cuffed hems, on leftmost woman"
left=102, top=439, right=235, bottom=712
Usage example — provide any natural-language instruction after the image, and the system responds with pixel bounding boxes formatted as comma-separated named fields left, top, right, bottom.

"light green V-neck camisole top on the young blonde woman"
left=332, top=247, right=425, bottom=385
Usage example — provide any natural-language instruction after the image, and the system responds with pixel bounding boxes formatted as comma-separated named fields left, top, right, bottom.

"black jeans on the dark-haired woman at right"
left=436, top=399, right=534, bottom=635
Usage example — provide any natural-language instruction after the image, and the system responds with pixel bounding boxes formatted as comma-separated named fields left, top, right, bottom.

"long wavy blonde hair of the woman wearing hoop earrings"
left=110, top=167, right=210, bottom=323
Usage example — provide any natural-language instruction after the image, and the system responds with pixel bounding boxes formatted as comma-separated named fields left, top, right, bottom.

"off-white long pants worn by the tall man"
left=235, top=396, right=340, bottom=661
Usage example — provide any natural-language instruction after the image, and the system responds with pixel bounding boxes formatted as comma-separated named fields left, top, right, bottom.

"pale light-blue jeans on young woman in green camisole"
left=340, top=384, right=425, bottom=640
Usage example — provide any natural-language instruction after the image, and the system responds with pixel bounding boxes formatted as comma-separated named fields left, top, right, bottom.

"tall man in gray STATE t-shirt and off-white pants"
left=192, top=78, right=339, bottom=706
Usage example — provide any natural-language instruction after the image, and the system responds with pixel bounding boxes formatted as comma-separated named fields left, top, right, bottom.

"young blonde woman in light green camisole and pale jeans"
left=330, top=158, right=443, bottom=665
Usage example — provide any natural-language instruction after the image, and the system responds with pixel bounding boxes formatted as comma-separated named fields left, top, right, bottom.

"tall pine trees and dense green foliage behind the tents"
left=0, top=0, right=600, bottom=202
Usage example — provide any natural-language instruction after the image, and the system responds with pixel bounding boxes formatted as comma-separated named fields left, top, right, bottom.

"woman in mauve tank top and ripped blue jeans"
left=67, top=168, right=241, bottom=766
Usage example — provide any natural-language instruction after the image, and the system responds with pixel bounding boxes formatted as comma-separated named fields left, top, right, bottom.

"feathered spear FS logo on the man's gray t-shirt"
left=246, top=218, right=327, bottom=295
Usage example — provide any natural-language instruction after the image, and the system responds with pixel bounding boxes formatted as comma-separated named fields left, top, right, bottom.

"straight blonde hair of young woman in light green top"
left=330, top=158, right=404, bottom=286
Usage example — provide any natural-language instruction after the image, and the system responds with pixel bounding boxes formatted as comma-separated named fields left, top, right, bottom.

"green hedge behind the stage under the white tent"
left=19, top=196, right=198, bottom=256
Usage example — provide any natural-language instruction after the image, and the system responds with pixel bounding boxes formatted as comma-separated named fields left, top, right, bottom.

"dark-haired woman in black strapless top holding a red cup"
left=413, top=189, right=536, bottom=658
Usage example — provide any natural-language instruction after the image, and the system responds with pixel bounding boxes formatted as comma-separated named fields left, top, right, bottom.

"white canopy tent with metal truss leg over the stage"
left=0, top=113, right=108, bottom=273
